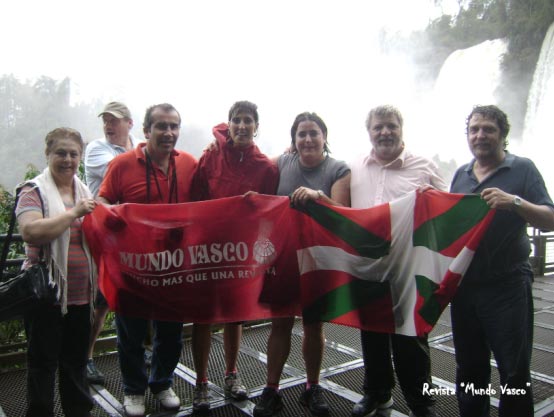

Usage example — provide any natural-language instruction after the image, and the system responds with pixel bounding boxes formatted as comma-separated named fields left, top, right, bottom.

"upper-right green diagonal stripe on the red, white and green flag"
left=413, top=195, right=489, bottom=252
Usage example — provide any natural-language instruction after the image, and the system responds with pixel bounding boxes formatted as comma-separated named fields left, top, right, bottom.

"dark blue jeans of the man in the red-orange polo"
left=115, top=314, right=183, bottom=395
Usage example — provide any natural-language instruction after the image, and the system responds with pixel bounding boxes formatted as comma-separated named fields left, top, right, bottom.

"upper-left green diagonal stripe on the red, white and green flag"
left=294, top=200, right=390, bottom=259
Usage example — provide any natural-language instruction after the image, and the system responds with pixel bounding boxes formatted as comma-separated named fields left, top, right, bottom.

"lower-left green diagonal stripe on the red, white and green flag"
left=302, top=279, right=390, bottom=321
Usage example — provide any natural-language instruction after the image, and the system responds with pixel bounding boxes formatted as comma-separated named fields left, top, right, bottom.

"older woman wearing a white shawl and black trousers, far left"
left=16, top=128, right=96, bottom=417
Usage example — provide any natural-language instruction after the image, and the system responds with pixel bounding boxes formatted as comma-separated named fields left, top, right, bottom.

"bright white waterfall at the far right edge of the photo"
left=523, top=23, right=554, bottom=191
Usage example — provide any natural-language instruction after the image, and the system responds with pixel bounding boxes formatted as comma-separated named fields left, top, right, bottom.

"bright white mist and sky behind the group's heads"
left=0, top=0, right=548, bottom=189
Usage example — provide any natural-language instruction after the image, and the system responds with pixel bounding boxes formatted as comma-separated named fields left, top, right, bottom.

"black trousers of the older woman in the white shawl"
left=25, top=304, right=94, bottom=417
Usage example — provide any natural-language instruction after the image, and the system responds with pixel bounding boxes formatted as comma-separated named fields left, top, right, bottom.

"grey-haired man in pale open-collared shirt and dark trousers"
left=350, top=106, right=448, bottom=417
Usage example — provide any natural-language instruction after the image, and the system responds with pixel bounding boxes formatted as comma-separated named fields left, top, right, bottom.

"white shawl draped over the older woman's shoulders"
left=20, top=167, right=97, bottom=314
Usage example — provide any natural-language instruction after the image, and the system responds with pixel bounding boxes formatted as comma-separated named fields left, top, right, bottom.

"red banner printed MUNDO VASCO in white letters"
left=83, top=195, right=300, bottom=323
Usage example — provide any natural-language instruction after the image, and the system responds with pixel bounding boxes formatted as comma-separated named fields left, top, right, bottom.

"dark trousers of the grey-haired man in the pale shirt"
left=361, top=331, right=435, bottom=414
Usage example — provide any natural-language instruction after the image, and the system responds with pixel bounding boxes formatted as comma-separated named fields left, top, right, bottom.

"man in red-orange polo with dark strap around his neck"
left=98, top=104, right=197, bottom=416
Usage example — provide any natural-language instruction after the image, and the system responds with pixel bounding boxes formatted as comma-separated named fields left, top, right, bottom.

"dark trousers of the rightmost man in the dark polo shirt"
left=451, top=276, right=533, bottom=417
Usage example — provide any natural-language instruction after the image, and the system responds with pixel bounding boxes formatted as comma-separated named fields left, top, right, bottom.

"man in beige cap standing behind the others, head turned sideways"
left=85, top=101, right=139, bottom=385
